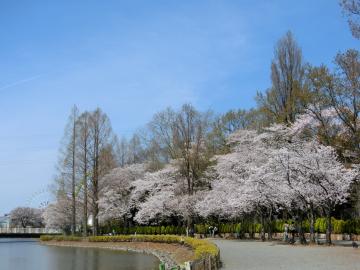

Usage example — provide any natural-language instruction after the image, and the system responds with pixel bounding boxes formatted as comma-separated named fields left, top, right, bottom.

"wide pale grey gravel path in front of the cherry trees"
left=212, top=239, right=360, bottom=270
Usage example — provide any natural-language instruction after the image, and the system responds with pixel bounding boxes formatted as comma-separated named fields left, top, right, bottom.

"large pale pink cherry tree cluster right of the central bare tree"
left=196, top=120, right=357, bottom=243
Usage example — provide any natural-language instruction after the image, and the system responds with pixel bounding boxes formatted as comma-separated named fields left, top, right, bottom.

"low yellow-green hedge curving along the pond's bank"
left=40, top=235, right=220, bottom=260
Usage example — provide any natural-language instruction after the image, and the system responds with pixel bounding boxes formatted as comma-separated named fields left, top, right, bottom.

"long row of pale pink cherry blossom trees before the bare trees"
left=93, top=115, right=358, bottom=245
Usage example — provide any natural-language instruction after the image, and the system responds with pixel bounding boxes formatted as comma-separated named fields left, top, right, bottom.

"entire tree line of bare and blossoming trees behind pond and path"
left=44, top=1, right=360, bottom=245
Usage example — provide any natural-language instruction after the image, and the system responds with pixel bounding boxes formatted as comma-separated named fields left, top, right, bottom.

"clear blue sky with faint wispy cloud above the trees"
left=0, top=0, right=359, bottom=214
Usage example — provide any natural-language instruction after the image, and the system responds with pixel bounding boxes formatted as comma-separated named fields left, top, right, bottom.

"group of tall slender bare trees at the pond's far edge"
left=44, top=106, right=118, bottom=234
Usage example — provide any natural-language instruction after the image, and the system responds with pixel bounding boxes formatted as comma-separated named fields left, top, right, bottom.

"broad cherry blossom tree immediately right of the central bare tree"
left=197, top=130, right=288, bottom=237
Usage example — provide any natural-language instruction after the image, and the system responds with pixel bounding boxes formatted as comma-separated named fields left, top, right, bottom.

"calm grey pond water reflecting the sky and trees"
left=0, top=238, right=159, bottom=270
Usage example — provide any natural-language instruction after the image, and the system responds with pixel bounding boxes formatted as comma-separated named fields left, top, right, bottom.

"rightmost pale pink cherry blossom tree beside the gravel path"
left=290, top=140, right=358, bottom=244
